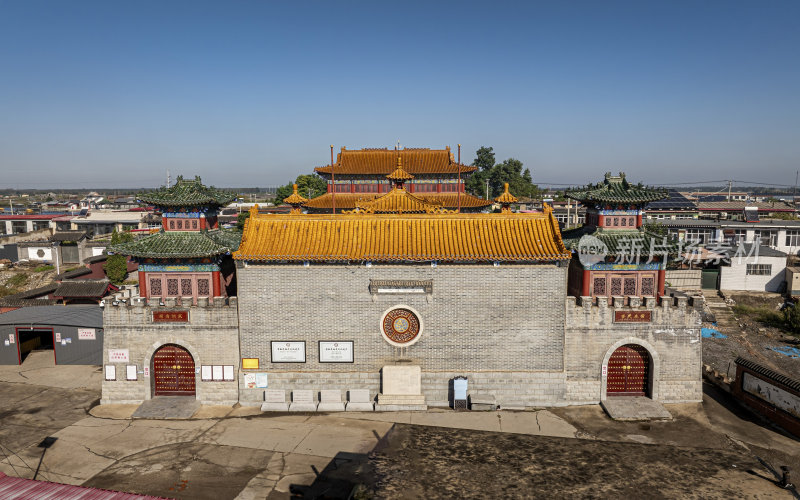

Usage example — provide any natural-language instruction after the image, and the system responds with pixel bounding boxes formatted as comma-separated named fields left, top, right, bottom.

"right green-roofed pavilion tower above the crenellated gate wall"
left=563, top=172, right=676, bottom=303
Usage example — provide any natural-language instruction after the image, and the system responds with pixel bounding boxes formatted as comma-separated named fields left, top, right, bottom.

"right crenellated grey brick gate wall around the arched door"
left=565, top=297, right=703, bottom=404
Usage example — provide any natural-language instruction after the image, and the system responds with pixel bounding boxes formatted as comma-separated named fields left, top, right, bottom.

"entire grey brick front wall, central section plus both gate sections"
left=102, top=263, right=702, bottom=407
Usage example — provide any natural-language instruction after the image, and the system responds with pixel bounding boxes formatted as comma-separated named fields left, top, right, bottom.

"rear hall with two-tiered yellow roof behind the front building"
left=305, top=147, right=492, bottom=213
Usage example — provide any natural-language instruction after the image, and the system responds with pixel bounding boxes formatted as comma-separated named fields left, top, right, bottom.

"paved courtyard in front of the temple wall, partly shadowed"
left=0, top=356, right=800, bottom=499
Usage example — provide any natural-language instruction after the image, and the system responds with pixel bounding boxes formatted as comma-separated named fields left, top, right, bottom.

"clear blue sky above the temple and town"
left=0, top=0, right=800, bottom=188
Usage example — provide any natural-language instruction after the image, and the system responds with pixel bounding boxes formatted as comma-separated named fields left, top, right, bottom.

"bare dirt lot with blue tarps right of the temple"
left=703, top=294, right=800, bottom=379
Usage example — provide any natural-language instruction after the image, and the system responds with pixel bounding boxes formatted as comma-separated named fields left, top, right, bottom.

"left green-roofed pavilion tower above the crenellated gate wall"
left=109, top=176, right=241, bottom=304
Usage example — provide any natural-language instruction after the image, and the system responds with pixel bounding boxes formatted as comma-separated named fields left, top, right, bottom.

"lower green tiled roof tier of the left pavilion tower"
left=108, top=230, right=242, bottom=259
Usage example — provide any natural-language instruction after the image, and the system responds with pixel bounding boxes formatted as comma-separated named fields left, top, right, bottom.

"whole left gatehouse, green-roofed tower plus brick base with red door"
left=102, top=177, right=241, bottom=404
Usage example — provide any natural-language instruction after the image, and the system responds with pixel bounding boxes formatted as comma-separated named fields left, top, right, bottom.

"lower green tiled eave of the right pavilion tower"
left=561, top=226, right=680, bottom=257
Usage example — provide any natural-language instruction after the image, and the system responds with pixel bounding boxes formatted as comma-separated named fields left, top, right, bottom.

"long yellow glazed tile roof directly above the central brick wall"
left=233, top=211, right=570, bottom=262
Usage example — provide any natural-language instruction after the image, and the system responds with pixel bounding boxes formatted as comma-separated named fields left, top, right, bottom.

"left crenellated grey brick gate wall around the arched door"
left=101, top=297, right=240, bottom=404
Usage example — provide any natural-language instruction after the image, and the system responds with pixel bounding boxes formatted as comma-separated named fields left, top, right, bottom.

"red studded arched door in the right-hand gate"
left=606, top=344, right=650, bottom=396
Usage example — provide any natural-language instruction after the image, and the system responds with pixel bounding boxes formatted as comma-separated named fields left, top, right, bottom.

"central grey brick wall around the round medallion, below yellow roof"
left=237, top=263, right=567, bottom=405
